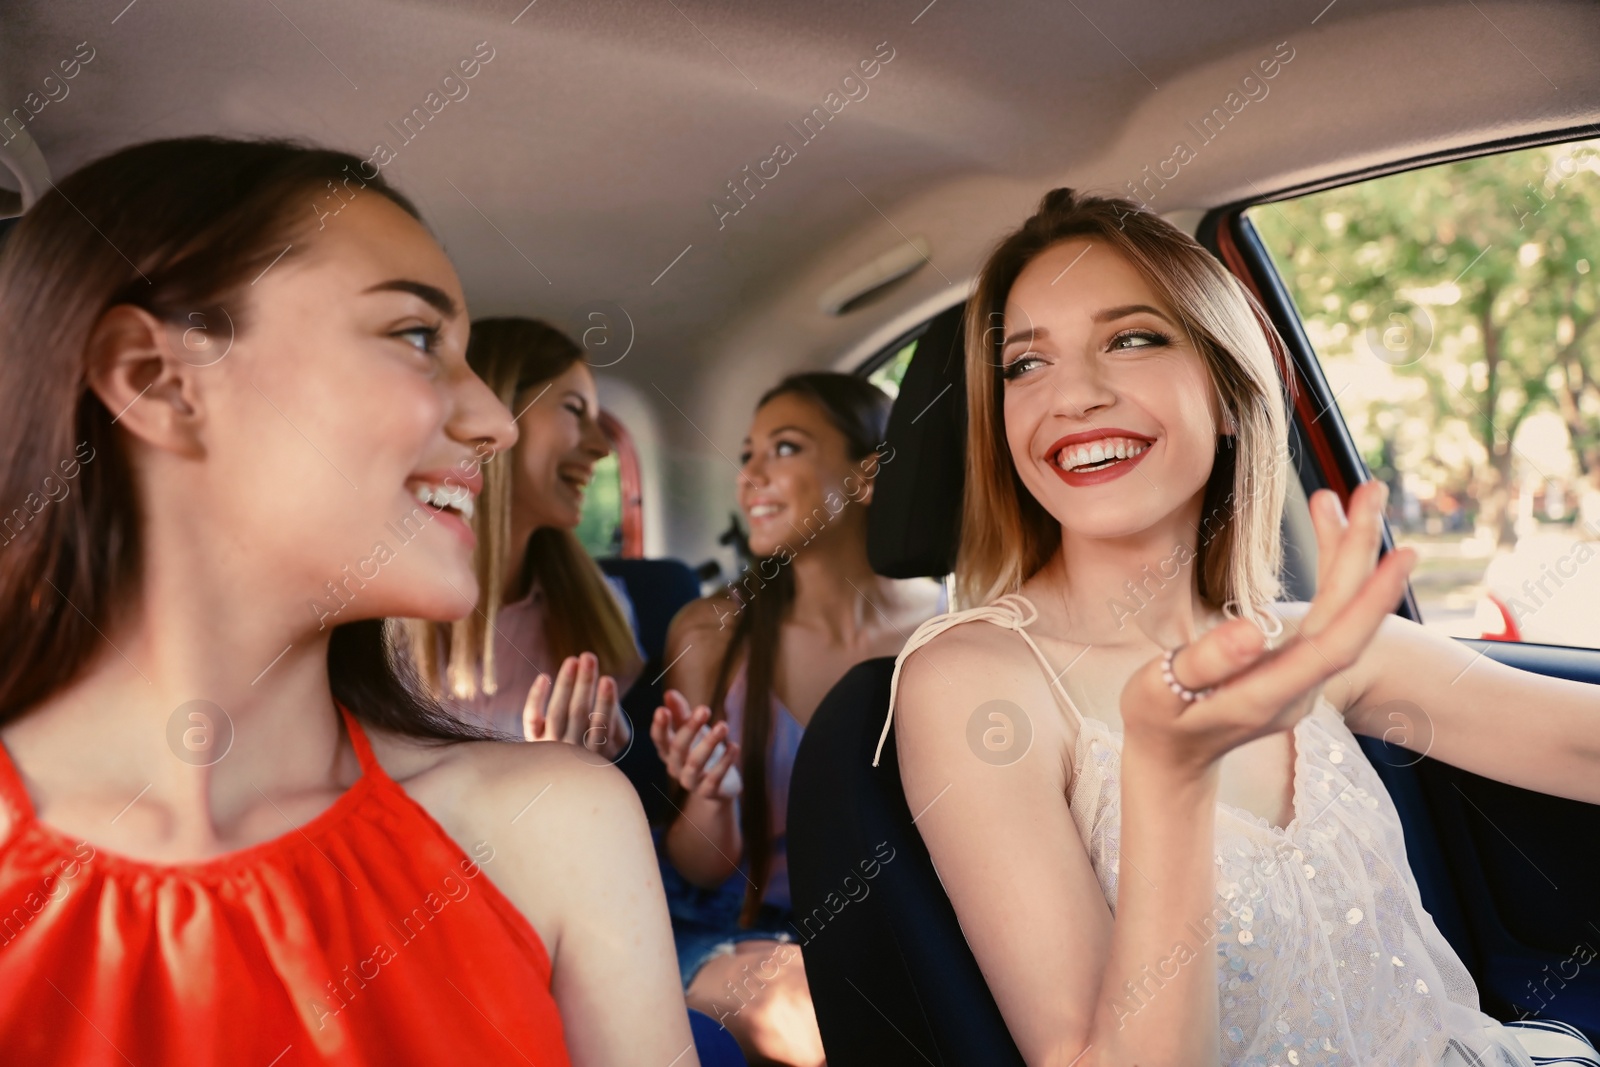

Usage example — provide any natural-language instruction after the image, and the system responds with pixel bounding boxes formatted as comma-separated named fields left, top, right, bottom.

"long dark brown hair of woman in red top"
left=0, top=138, right=483, bottom=739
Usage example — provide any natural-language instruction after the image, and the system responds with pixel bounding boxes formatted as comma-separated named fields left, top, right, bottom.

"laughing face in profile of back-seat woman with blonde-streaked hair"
left=510, top=360, right=611, bottom=533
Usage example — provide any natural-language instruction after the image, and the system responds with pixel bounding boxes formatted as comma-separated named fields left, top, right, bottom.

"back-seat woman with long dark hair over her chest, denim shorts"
left=651, top=373, right=944, bottom=1064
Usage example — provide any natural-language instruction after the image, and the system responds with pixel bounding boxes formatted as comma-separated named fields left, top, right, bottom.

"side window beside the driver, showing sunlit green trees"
left=1246, top=139, right=1600, bottom=648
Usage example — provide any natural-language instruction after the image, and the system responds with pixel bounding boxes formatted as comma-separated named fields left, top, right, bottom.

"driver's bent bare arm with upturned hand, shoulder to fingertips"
left=898, top=486, right=1414, bottom=1067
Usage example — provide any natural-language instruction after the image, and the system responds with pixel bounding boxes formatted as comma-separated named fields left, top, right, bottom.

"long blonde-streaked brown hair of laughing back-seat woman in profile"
left=408, top=318, right=640, bottom=699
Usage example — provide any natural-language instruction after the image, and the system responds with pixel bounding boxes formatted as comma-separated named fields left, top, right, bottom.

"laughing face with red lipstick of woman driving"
left=1000, top=238, right=1219, bottom=542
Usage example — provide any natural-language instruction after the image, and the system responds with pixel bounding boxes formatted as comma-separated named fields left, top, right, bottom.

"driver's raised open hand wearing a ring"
left=1122, top=482, right=1416, bottom=774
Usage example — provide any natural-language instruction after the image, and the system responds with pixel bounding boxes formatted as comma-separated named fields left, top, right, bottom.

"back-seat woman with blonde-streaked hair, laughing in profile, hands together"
left=406, top=318, right=643, bottom=751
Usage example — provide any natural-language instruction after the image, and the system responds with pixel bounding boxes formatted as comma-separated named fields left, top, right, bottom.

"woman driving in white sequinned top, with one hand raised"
left=885, top=189, right=1600, bottom=1067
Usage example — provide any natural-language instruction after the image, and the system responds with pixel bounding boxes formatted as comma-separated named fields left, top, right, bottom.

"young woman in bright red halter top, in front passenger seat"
left=0, top=139, right=696, bottom=1067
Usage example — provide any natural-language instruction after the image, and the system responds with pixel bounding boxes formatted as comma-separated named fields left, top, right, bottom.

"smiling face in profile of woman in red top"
left=188, top=195, right=515, bottom=624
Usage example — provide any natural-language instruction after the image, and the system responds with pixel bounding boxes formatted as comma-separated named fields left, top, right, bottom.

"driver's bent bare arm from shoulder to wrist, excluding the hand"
left=894, top=622, right=1218, bottom=1067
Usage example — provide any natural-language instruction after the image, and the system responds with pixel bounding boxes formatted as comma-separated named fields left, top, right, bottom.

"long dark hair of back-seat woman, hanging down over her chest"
left=710, top=371, right=891, bottom=926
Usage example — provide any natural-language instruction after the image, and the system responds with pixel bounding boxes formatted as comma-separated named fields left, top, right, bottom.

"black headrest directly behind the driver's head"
left=867, top=304, right=966, bottom=577
